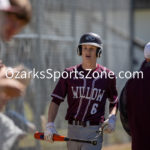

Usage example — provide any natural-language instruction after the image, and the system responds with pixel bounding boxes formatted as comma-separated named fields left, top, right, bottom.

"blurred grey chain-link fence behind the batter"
left=0, top=0, right=131, bottom=150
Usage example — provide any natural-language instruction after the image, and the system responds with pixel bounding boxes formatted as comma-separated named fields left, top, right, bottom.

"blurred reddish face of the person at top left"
left=0, top=14, right=25, bottom=41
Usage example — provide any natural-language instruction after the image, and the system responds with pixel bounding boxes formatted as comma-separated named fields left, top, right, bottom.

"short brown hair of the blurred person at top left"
left=1, top=0, right=32, bottom=23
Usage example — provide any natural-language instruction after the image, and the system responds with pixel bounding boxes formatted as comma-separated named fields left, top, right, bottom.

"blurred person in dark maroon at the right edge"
left=119, top=42, right=150, bottom=150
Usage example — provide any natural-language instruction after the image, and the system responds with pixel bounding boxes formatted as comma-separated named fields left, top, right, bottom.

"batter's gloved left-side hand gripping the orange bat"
left=44, top=122, right=57, bottom=143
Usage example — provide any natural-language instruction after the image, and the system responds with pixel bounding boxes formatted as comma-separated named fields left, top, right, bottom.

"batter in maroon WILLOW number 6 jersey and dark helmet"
left=44, top=33, right=118, bottom=150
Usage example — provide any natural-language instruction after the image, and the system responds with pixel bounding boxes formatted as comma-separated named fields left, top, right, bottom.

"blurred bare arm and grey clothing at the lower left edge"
left=0, top=63, right=35, bottom=150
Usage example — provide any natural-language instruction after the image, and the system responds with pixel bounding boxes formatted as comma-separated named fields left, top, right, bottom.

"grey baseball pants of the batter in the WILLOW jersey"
left=67, top=124, right=103, bottom=150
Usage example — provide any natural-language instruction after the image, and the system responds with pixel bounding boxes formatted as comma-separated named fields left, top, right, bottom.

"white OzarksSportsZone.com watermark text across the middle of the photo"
left=6, top=68, right=144, bottom=82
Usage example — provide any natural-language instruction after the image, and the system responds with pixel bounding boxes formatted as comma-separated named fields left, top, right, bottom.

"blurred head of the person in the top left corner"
left=0, top=0, right=31, bottom=41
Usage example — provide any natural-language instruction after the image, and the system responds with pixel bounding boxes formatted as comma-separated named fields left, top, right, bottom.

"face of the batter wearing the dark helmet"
left=82, top=45, right=97, bottom=63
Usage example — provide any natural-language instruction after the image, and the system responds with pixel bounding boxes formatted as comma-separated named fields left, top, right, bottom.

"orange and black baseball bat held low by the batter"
left=34, top=132, right=97, bottom=145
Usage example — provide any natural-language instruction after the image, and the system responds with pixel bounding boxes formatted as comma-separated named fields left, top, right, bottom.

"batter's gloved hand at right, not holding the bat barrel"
left=102, top=114, right=116, bottom=133
